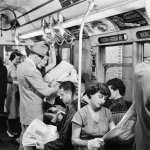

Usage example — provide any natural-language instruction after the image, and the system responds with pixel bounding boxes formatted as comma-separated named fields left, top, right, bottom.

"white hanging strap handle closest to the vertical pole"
left=54, top=13, right=75, bottom=44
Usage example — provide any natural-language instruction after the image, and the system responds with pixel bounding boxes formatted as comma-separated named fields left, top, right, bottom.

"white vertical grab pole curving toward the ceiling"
left=78, top=0, right=94, bottom=109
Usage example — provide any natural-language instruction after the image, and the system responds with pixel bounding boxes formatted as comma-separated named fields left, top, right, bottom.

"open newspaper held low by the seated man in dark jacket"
left=22, top=119, right=58, bottom=146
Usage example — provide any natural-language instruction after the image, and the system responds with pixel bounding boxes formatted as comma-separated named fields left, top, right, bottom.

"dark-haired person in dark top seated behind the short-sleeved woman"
left=105, top=78, right=128, bottom=113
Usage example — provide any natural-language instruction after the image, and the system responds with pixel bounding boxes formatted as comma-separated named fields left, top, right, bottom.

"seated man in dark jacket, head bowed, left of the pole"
left=36, top=81, right=77, bottom=150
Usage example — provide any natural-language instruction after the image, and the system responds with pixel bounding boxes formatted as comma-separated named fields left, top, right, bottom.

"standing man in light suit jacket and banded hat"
left=17, top=44, right=58, bottom=150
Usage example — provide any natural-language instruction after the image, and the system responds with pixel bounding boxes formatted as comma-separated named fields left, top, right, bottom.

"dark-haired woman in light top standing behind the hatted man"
left=6, top=52, right=21, bottom=137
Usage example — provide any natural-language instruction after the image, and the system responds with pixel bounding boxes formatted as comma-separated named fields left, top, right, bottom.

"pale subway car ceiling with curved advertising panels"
left=0, top=0, right=150, bottom=46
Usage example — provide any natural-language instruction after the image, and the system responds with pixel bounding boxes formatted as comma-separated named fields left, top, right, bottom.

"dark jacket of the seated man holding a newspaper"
left=44, top=100, right=77, bottom=150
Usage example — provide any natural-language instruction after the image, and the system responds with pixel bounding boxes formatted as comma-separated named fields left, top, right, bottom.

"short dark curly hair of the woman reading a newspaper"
left=86, top=82, right=110, bottom=98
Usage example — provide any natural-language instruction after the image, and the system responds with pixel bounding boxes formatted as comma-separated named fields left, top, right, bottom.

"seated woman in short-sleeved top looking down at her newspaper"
left=72, top=83, right=115, bottom=150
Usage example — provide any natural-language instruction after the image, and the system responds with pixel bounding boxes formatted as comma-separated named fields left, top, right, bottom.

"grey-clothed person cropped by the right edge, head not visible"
left=134, top=58, right=150, bottom=150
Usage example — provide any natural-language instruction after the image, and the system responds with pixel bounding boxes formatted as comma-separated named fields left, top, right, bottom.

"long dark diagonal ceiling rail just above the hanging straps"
left=17, top=0, right=87, bottom=28
